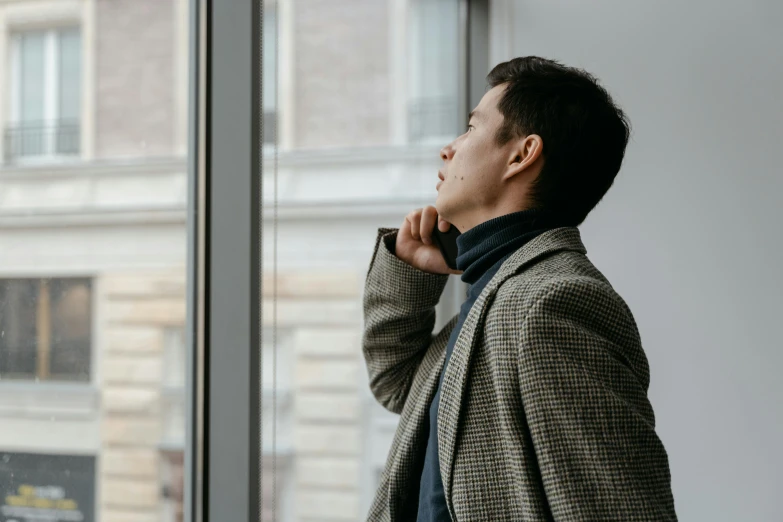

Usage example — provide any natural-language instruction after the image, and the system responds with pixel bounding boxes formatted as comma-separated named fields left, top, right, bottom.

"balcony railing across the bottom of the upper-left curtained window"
left=4, top=120, right=81, bottom=165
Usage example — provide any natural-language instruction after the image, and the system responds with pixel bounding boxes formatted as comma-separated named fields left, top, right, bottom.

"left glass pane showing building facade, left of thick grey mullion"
left=0, top=0, right=191, bottom=522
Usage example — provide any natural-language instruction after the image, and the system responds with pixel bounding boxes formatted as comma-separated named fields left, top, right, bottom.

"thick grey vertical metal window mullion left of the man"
left=201, top=0, right=262, bottom=522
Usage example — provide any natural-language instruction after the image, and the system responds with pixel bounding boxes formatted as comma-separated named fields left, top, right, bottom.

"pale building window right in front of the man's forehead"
left=408, top=0, right=460, bottom=144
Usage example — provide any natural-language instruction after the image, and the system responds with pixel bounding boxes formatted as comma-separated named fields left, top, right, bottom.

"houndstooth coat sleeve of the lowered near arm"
left=518, top=279, right=677, bottom=521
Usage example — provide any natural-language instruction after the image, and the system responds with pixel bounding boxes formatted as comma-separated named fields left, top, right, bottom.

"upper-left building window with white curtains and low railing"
left=5, top=27, right=82, bottom=164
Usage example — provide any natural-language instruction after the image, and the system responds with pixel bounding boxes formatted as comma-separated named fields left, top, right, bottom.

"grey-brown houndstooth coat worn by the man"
left=362, top=227, right=676, bottom=522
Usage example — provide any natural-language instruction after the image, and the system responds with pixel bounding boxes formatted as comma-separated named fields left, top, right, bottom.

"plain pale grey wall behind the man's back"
left=490, top=0, right=783, bottom=521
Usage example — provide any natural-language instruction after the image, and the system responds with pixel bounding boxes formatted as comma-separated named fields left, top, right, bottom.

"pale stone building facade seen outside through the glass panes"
left=0, top=0, right=466, bottom=522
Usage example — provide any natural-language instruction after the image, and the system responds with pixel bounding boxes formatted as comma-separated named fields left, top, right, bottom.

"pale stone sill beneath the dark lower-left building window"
left=0, top=381, right=99, bottom=419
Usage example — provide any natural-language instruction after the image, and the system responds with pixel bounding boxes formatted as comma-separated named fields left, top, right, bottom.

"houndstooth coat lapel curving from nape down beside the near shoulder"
left=438, top=227, right=587, bottom=520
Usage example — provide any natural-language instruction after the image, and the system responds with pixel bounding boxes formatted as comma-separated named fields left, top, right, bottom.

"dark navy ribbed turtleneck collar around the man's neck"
left=457, top=210, right=554, bottom=285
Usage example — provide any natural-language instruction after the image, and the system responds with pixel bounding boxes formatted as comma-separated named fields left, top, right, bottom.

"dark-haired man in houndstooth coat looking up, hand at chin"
left=363, top=57, right=676, bottom=522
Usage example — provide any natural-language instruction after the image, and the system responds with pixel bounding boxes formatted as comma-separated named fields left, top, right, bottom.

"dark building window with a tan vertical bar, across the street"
left=0, top=279, right=92, bottom=382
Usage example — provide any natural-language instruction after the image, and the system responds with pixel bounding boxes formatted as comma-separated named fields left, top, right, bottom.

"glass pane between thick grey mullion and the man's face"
left=261, top=0, right=467, bottom=521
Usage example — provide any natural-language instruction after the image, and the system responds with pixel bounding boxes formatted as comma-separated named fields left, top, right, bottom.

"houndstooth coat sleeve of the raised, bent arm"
left=362, top=228, right=448, bottom=413
